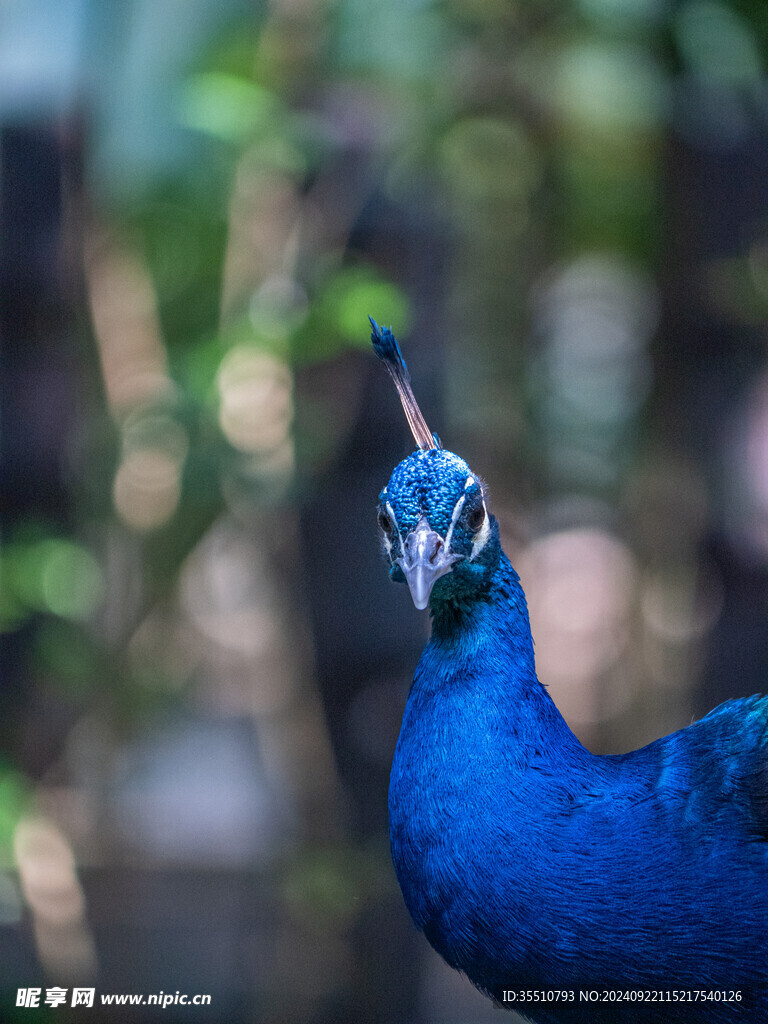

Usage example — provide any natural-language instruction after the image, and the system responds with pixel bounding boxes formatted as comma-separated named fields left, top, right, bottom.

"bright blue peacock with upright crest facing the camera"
left=371, top=318, right=768, bottom=1024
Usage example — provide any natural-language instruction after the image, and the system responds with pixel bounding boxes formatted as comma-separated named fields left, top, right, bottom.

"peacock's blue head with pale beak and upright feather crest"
left=371, top=319, right=500, bottom=608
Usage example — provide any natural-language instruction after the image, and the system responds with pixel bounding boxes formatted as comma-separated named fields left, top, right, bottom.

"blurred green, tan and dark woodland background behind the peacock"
left=0, top=0, right=768, bottom=1024
